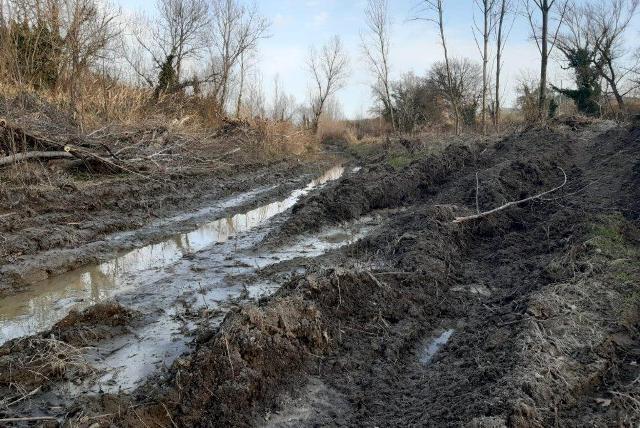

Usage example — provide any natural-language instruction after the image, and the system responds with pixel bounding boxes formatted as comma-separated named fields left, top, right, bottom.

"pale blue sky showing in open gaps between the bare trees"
left=118, top=0, right=640, bottom=118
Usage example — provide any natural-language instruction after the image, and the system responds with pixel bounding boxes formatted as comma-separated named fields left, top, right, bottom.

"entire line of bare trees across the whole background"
left=0, top=0, right=640, bottom=133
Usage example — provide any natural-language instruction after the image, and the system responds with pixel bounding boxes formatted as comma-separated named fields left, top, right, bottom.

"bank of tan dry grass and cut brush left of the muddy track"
left=0, top=83, right=318, bottom=181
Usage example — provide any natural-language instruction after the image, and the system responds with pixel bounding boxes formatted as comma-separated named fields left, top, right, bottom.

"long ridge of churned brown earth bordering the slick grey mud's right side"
left=130, top=203, right=468, bottom=426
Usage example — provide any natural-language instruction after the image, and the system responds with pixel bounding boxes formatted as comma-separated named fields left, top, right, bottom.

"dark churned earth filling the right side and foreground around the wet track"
left=0, top=118, right=640, bottom=427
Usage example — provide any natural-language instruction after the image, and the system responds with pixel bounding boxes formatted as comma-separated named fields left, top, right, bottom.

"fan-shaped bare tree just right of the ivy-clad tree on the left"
left=211, top=0, right=271, bottom=112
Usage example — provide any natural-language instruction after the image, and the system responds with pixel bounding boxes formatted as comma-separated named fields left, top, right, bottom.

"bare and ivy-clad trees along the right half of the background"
left=362, top=0, right=640, bottom=133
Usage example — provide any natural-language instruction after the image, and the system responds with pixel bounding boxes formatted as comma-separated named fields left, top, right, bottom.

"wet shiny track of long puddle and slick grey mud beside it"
left=0, top=166, right=372, bottom=401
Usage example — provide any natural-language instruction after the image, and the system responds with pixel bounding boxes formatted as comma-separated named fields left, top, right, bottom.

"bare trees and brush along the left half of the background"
left=0, top=0, right=348, bottom=129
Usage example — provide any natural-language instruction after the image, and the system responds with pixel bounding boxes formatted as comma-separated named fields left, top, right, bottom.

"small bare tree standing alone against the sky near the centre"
left=307, top=36, right=349, bottom=132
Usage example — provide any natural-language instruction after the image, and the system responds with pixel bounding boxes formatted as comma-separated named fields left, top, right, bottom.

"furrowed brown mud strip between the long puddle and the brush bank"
left=0, top=157, right=336, bottom=296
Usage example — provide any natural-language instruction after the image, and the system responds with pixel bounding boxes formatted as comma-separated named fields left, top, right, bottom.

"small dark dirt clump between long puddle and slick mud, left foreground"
left=46, top=302, right=138, bottom=346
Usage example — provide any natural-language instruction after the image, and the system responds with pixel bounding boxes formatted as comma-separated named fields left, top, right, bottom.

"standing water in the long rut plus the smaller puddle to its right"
left=0, top=166, right=344, bottom=343
